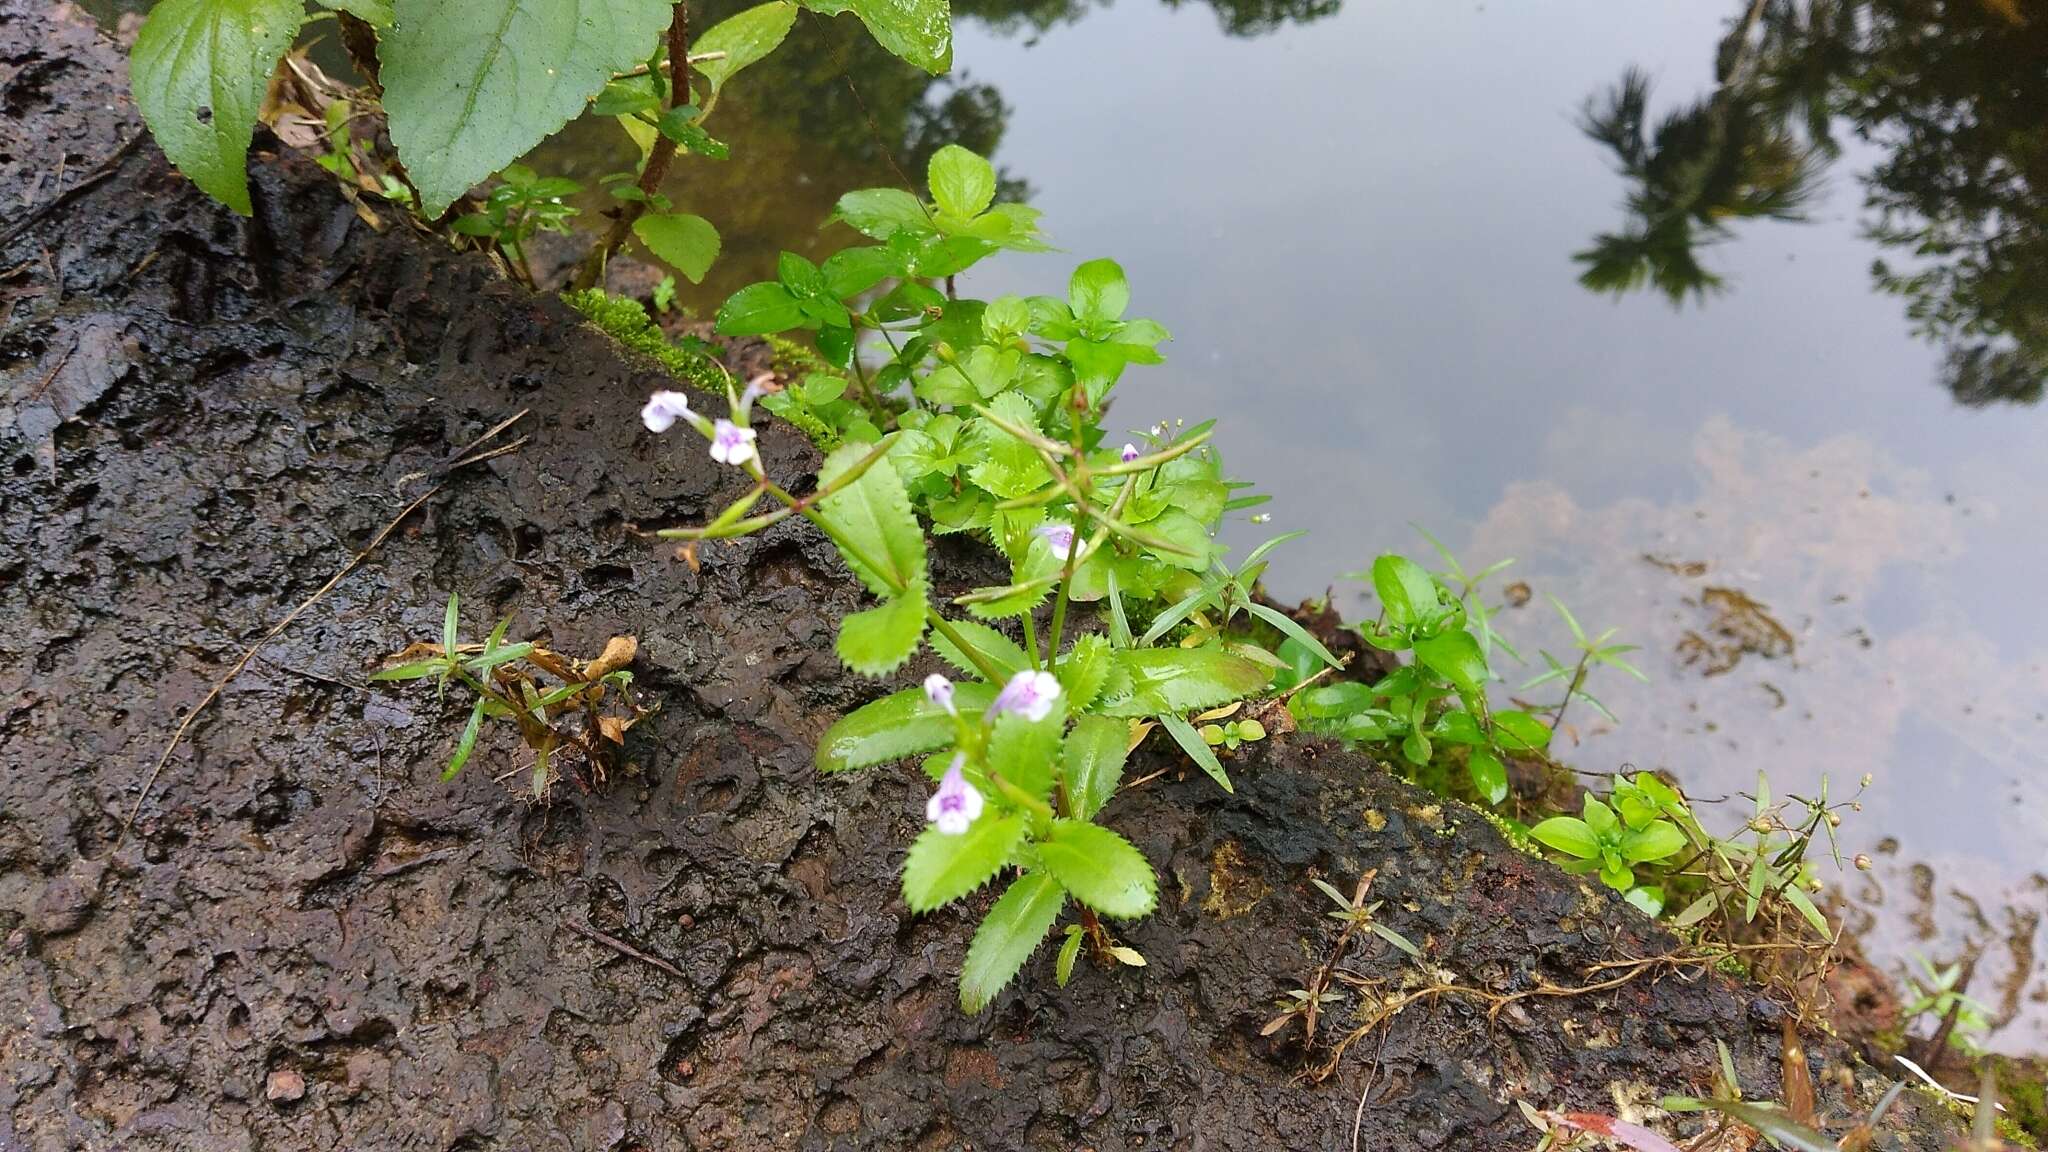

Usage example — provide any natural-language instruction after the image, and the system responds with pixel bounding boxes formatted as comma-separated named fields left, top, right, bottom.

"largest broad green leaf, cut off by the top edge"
left=377, top=0, right=674, bottom=217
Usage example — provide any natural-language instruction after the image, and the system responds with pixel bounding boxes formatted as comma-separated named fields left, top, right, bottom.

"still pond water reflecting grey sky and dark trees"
left=541, top=0, right=2048, bottom=1050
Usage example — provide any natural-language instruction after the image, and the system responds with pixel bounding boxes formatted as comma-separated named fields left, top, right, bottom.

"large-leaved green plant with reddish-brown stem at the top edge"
left=131, top=0, right=952, bottom=287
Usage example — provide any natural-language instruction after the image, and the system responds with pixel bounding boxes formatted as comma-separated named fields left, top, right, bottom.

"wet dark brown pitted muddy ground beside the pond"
left=0, top=0, right=1948, bottom=1152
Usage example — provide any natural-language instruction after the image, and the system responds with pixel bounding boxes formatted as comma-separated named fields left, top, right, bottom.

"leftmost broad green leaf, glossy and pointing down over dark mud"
left=129, top=0, right=305, bottom=215
